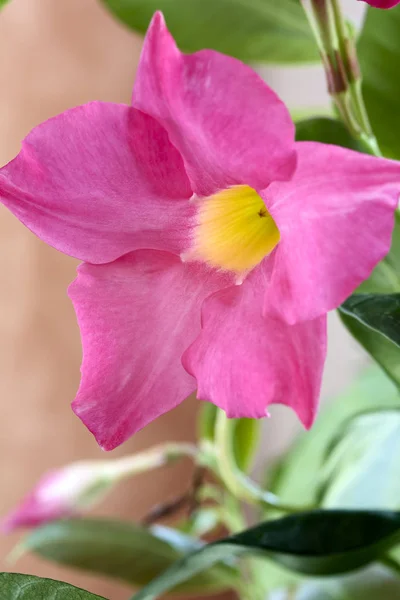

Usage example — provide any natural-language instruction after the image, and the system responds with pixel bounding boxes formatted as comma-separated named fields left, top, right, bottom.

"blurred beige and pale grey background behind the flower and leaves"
left=0, top=0, right=364, bottom=600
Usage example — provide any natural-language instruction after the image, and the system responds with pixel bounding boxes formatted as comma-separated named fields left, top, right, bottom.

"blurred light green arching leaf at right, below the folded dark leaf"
left=269, top=368, right=400, bottom=505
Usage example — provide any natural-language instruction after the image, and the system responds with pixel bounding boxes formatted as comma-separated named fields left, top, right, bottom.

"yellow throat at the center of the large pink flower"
left=189, top=185, right=280, bottom=275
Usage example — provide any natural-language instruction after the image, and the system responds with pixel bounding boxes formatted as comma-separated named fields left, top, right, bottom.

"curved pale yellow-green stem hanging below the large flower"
left=215, top=410, right=315, bottom=513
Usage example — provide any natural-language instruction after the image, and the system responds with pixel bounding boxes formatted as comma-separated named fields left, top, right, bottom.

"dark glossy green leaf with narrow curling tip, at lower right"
left=132, top=511, right=400, bottom=600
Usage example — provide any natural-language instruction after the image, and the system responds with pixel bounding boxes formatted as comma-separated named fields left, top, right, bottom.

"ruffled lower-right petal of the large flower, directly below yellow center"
left=183, top=269, right=326, bottom=427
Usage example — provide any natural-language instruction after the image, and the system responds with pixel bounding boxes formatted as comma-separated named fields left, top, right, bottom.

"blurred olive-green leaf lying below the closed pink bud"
left=24, top=519, right=236, bottom=593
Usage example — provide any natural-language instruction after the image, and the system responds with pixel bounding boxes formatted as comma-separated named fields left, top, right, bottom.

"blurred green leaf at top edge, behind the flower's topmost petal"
left=103, top=0, right=319, bottom=63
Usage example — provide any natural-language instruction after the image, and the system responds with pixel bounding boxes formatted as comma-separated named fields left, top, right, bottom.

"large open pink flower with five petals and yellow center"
left=0, top=13, right=400, bottom=450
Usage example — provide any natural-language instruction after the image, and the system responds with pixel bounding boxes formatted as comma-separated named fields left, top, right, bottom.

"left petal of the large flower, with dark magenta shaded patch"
left=0, top=102, right=193, bottom=263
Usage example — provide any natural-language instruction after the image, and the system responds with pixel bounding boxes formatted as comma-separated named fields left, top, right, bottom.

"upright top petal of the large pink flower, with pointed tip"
left=133, top=13, right=296, bottom=196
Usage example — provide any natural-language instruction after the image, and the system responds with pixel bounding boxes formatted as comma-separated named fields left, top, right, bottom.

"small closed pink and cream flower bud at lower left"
left=2, top=461, right=113, bottom=533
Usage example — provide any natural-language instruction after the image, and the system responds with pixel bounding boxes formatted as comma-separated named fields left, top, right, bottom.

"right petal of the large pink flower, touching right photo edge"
left=261, top=142, right=400, bottom=324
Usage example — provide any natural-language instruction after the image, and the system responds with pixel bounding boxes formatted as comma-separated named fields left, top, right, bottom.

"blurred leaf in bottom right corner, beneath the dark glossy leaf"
left=290, top=566, right=400, bottom=600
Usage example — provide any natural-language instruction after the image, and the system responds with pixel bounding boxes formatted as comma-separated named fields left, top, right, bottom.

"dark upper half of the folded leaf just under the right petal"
left=339, top=294, right=400, bottom=346
